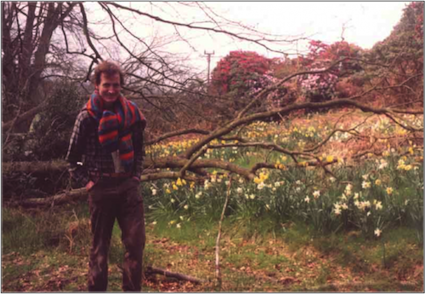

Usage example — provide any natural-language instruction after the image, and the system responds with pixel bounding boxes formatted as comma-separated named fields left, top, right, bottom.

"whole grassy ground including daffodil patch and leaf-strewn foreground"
left=2, top=111, right=424, bottom=292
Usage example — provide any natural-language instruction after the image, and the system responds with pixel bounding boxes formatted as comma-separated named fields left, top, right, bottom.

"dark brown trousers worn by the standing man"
left=88, top=178, right=146, bottom=293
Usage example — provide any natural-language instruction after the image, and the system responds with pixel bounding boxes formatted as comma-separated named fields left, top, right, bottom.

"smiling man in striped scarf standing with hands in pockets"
left=66, top=61, right=146, bottom=292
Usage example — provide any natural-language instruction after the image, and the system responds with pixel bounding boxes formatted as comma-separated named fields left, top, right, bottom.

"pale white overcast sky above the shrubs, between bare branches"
left=86, top=1, right=410, bottom=78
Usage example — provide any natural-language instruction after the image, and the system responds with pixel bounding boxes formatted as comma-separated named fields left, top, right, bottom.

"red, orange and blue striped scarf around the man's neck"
left=86, top=90, right=146, bottom=172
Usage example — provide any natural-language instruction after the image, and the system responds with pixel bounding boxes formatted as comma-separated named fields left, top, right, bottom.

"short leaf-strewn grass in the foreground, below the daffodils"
left=2, top=203, right=424, bottom=292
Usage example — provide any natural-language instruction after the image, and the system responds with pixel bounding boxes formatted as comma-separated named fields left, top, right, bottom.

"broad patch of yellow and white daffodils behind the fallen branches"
left=144, top=113, right=424, bottom=241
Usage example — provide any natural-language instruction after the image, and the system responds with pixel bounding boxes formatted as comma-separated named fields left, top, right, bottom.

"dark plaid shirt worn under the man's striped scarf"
left=66, top=108, right=145, bottom=186
